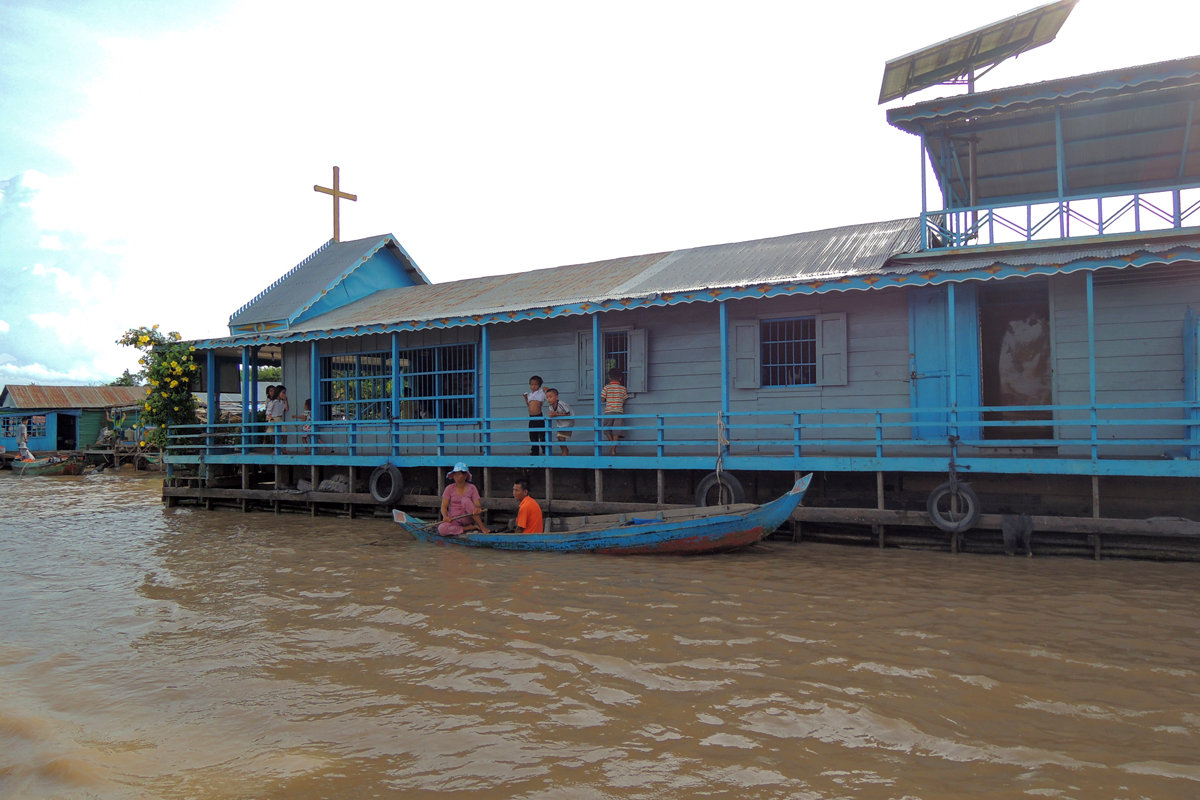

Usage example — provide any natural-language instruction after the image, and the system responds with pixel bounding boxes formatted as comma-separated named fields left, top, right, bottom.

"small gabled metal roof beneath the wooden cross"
left=229, top=234, right=428, bottom=326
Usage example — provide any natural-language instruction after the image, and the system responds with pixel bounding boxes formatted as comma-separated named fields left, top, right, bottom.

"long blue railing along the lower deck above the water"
left=167, top=402, right=1200, bottom=477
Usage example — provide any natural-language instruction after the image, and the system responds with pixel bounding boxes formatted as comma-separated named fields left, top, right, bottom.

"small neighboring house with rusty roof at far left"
left=0, top=384, right=146, bottom=453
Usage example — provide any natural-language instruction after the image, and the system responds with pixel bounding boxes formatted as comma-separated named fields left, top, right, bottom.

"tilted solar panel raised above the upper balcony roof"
left=880, top=0, right=1078, bottom=103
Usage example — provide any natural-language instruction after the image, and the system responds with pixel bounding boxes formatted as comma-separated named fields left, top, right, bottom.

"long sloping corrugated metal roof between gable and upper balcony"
left=289, top=218, right=920, bottom=332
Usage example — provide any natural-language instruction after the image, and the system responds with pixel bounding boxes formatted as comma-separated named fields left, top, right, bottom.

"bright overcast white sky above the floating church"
left=0, top=0, right=1200, bottom=384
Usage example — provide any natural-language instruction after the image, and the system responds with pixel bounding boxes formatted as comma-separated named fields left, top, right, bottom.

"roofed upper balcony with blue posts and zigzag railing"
left=888, top=56, right=1200, bottom=251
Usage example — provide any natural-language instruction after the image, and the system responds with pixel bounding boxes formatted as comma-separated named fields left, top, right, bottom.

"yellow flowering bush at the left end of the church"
left=116, top=325, right=196, bottom=447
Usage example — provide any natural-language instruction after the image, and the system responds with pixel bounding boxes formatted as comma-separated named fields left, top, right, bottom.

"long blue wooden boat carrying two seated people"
left=392, top=475, right=812, bottom=555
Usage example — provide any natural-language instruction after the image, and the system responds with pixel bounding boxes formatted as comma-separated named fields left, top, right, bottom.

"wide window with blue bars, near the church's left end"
left=320, top=344, right=475, bottom=420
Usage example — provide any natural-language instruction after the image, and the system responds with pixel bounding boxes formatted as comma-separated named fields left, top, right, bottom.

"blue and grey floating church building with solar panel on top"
left=164, top=0, right=1200, bottom=556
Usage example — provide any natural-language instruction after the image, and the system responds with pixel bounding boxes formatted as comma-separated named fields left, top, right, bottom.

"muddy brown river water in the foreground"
left=0, top=473, right=1200, bottom=800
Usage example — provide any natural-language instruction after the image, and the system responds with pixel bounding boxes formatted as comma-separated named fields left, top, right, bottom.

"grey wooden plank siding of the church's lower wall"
left=236, top=267, right=1200, bottom=465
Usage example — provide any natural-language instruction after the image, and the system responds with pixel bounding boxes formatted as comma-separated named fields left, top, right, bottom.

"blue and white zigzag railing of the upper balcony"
left=922, top=184, right=1200, bottom=249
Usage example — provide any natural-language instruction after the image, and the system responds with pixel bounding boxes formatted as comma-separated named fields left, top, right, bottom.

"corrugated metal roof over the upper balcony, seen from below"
left=888, top=58, right=1200, bottom=205
